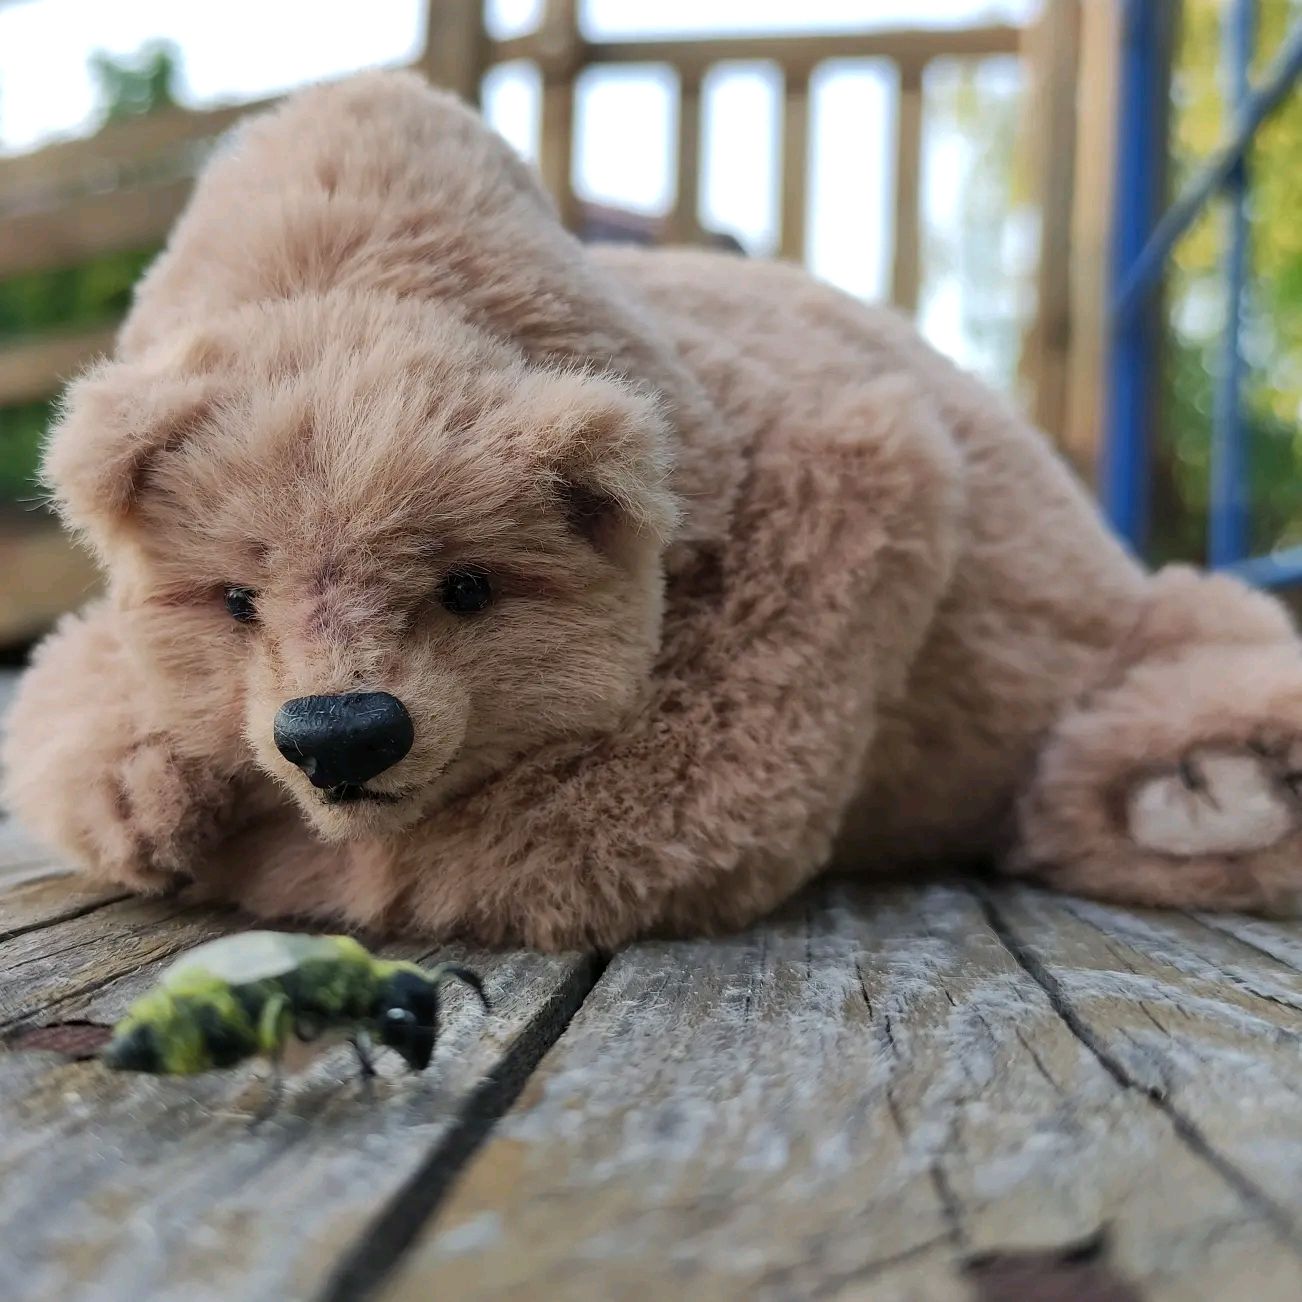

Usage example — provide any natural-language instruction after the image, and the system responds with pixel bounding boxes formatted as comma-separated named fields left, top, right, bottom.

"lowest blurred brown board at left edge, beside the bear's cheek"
left=0, top=517, right=100, bottom=646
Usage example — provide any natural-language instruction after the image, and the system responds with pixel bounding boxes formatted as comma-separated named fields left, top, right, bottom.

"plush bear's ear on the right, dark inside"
left=521, top=372, right=678, bottom=553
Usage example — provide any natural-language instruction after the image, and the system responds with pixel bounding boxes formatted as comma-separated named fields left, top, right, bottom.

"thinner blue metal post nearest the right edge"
left=1208, top=0, right=1256, bottom=565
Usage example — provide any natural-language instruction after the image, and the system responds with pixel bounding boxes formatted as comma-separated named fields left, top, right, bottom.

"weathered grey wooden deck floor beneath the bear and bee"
left=0, top=671, right=1302, bottom=1302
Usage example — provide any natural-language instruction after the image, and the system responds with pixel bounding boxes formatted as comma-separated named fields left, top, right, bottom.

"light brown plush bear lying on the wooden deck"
left=5, top=74, right=1302, bottom=948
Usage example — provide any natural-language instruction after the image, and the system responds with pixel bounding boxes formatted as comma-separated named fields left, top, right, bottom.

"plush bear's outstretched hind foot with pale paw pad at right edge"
left=1008, top=569, right=1302, bottom=914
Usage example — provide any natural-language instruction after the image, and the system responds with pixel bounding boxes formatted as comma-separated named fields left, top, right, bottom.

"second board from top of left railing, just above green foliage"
left=0, top=180, right=193, bottom=276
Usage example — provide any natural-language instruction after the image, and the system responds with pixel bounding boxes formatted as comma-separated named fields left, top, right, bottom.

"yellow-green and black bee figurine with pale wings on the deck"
left=100, top=931, right=491, bottom=1120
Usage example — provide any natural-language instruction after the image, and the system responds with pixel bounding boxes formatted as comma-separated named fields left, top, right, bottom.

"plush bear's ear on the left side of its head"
left=42, top=362, right=215, bottom=534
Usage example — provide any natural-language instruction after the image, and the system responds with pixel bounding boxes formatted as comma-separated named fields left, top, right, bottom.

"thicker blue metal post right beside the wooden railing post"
left=1099, top=0, right=1167, bottom=552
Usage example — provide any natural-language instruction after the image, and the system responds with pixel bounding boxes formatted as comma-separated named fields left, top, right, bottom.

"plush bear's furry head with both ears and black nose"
left=46, top=289, right=676, bottom=838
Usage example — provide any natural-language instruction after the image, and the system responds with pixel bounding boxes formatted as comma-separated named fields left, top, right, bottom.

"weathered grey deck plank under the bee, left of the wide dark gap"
left=0, top=904, right=594, bottom=1302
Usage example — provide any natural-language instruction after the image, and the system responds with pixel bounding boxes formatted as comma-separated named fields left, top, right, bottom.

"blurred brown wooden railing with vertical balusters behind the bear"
left=0, top=0, right=1101, bottom=641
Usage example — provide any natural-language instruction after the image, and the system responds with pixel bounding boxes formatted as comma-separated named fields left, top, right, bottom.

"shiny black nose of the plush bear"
left=272, top=691, right=415, bottom=788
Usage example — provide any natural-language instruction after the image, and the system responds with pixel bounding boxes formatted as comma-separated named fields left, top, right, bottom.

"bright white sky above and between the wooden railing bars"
left=0, top=0, right=1040, bottom=377
